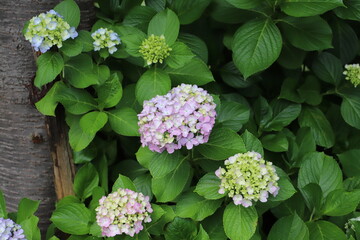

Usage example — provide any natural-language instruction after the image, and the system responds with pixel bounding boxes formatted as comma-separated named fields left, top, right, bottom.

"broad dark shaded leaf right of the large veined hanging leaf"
left=281, top=16, right=332, bottom=51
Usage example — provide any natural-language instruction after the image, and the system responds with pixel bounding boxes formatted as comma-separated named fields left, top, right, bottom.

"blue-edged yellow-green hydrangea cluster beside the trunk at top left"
left=25, top=10, right=78, bottom=53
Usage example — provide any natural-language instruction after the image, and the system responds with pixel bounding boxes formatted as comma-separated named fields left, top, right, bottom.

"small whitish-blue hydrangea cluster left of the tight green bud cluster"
left=91, top=28, right=121, bottom=54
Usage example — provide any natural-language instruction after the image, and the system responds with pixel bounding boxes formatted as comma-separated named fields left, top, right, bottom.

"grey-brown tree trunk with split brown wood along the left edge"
left=0, top=0, right=95, bottom=232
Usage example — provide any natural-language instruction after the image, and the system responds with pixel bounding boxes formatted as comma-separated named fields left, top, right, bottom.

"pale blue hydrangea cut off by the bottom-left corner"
left=0, top=218, right=26, bottom=240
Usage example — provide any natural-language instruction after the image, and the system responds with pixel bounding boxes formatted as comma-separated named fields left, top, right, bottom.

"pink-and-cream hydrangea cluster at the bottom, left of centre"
left=96, top=188, right=153, bottom=237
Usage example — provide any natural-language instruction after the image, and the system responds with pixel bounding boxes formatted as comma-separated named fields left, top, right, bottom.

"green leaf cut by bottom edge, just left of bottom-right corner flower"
left=306, top=220, right=347, bottom=240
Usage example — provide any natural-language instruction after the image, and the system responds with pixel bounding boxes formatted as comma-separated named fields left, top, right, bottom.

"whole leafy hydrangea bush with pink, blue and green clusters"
left=19, top=0, right=360, bottom=240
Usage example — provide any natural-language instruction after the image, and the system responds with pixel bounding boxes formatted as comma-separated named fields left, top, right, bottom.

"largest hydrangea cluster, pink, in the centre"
left=138, top=84, right=216, bottom=153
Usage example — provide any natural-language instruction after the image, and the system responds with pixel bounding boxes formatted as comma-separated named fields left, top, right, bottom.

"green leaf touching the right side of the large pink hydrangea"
left=216, top=101, right=250, bottom=132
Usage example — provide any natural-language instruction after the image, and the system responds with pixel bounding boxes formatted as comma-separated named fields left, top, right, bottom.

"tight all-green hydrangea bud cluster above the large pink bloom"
left=139, top=34, right=172, bottom=65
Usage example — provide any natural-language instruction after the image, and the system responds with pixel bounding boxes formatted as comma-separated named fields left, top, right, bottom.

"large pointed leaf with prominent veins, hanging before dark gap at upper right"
left=232, top=18, right=282, bottom=79
